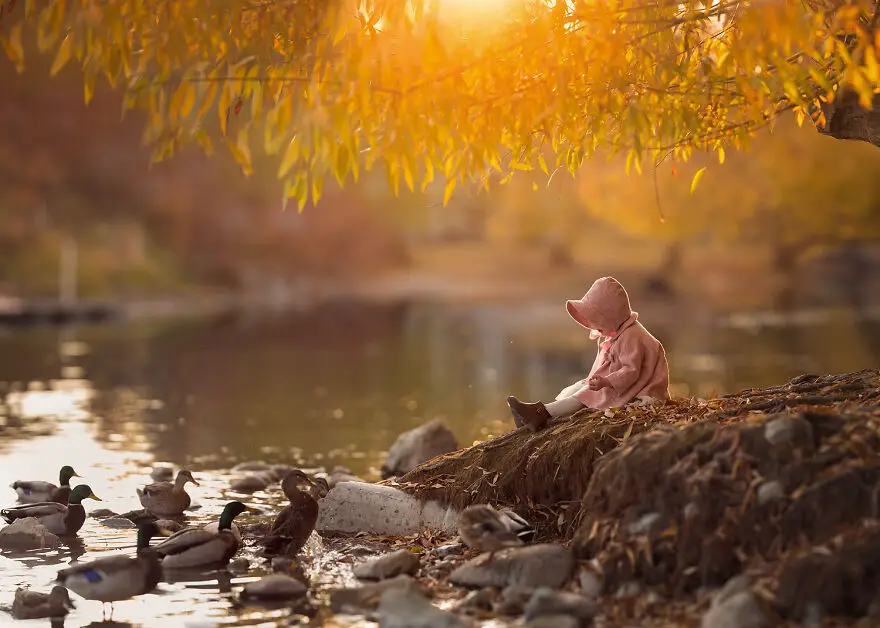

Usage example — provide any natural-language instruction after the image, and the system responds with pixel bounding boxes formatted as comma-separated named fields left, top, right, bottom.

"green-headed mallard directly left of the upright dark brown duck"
left=154, top=502, right=248, bottom=569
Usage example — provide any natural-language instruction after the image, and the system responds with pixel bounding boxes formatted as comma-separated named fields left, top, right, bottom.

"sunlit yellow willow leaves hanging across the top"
left=0, top=0, right=880, bottom=208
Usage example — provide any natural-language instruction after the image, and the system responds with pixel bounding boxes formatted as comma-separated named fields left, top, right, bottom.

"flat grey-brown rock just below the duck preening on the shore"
left=449, top=543, right=575, bottom=589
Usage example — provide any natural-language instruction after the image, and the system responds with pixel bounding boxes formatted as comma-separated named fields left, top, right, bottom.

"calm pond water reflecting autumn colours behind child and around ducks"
left=0, top=304, right=880, bottom=628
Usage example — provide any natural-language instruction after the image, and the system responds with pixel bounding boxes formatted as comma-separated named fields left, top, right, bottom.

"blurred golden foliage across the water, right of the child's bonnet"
left=579, top=116, right=880, bottom=254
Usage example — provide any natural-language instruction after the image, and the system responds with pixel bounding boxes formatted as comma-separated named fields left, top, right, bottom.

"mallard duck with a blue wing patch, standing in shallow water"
left=57, top=520, right=162, bottom=616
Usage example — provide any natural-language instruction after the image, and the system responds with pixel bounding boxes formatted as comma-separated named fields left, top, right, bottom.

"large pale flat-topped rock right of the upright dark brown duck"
left=315, top=482, right=458, bottom=536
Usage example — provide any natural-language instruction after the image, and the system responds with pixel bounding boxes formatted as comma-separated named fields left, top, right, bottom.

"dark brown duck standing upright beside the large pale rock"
left=259, top=469, right=326, bottom=555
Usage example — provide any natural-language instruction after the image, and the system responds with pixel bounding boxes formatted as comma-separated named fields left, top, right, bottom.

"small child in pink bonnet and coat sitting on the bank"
left=507, top=277, right=669, bottom=431
